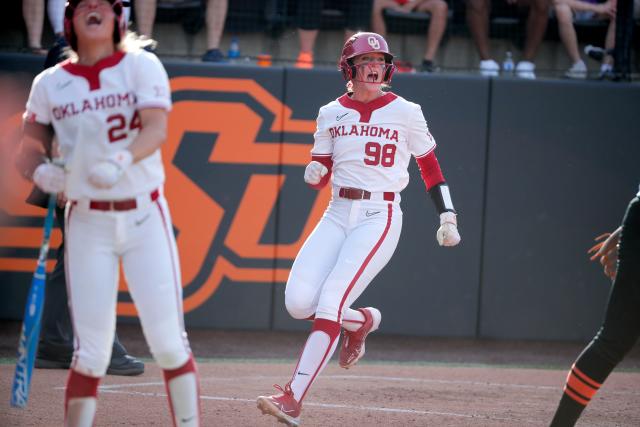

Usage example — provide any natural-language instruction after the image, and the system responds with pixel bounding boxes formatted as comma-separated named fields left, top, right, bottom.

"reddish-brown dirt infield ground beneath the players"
left=0, top=322, right=640, bottom=426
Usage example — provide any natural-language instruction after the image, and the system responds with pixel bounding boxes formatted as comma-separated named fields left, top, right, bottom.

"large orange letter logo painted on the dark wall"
left=0, top=76, right=330, bottom=316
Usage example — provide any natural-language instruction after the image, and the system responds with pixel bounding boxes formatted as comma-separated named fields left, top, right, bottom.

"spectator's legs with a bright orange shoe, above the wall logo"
left=295, top=0, right=372, bottom=68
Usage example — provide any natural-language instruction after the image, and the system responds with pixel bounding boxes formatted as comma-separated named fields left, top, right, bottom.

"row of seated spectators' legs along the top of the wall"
left=23, top=0, right=640, bottom=79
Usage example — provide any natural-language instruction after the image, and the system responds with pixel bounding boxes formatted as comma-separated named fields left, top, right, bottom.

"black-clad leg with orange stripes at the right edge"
left=551, top=186, right=640, bottom=427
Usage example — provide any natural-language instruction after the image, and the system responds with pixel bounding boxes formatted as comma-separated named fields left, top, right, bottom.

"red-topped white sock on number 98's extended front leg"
left=291, top=319, right=340, bottom=402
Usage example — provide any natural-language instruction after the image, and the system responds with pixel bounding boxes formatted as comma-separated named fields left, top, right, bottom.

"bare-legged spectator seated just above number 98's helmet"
left=371, top=0, right=449, bottom=73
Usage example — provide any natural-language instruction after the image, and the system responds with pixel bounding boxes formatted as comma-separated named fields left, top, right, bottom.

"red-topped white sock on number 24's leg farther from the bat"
left=162, top=355, right=200, bottom=427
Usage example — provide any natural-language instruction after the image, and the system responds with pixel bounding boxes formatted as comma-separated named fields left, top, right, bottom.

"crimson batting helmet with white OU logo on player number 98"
left=338, top=33, right=396, bottom=83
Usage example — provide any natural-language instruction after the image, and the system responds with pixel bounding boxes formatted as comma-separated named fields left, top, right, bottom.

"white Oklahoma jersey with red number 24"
left=25, top=50, right=171, bottom=200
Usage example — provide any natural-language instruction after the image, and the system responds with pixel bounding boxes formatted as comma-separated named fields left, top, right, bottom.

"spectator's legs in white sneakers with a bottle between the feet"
left=466, top=0, right=549, bottom=79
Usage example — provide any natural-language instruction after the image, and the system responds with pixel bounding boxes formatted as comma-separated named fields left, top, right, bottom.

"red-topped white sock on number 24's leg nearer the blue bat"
left=64, top=369, right=100, bottom=427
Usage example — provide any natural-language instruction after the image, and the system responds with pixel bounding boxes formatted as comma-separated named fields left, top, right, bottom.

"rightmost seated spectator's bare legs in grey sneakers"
left=553, top=0, right=616, bottom=79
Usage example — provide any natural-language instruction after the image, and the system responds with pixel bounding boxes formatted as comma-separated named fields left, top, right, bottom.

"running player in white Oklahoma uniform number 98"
left=258, top=33, right=460, bottom=426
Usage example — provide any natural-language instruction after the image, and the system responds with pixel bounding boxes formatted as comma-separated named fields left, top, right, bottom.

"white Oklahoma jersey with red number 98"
left=311, top=93, right=436, bottom=192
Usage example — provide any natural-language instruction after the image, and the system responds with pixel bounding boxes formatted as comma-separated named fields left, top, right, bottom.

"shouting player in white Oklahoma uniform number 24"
left=25, top=0, right=200, bottom=426
